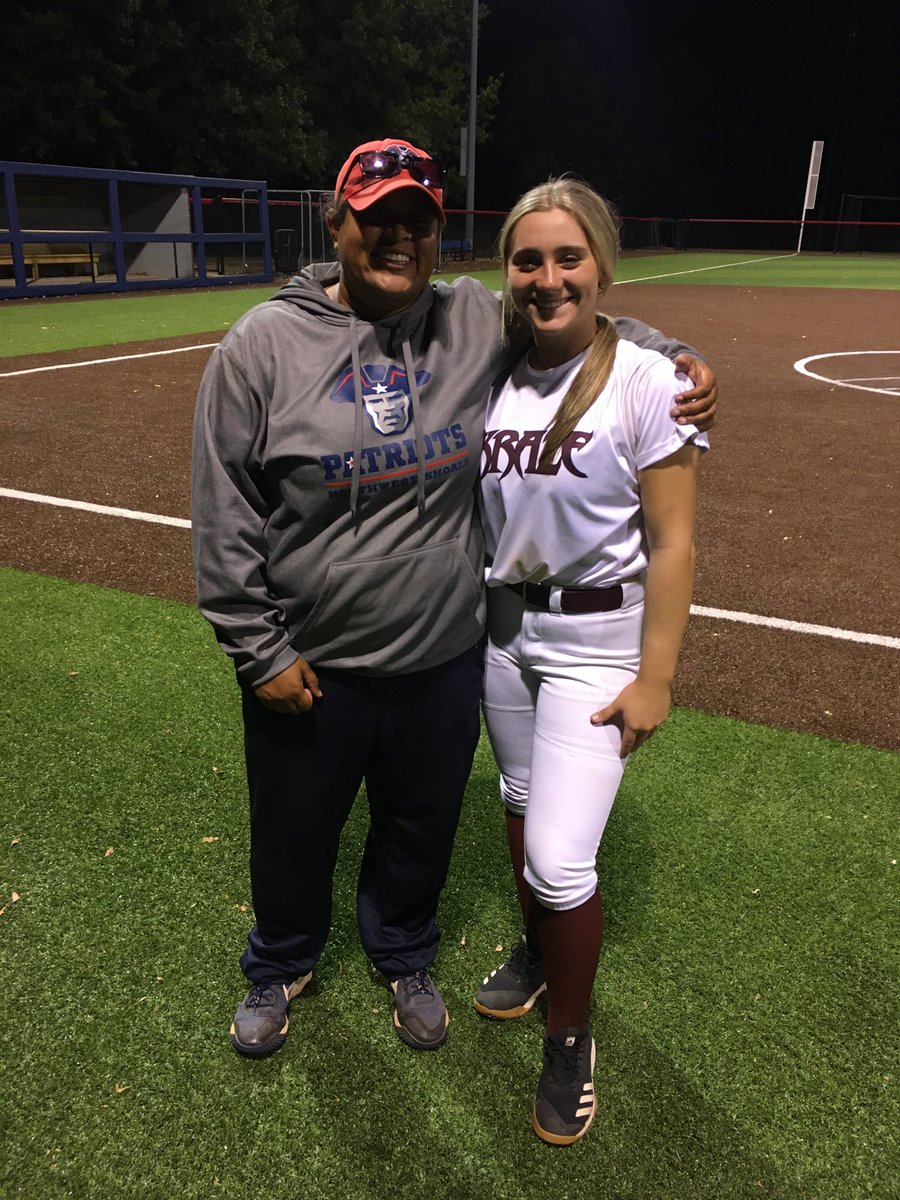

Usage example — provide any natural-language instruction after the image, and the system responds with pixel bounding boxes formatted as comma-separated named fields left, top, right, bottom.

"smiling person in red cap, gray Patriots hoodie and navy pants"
left=192, top=138, right=715, bottom=1057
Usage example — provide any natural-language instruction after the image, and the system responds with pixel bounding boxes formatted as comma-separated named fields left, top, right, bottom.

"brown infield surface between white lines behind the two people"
left=0, top=284, right=900, bottom=749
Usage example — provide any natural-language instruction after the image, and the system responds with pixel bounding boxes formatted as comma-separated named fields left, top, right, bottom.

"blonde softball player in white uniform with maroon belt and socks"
left=475, top=180, right=708, bottom=1145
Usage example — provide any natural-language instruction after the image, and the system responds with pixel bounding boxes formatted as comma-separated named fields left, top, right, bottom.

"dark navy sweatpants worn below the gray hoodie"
left=241, top=646, right=482, bottom=983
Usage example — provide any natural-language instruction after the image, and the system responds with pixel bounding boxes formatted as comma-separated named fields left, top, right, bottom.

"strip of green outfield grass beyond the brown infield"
left=0, top=251, right=900, bottom=359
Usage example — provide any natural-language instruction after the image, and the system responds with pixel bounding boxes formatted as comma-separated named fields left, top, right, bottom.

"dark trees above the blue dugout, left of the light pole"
left=0, top=0, right=499, bottom=197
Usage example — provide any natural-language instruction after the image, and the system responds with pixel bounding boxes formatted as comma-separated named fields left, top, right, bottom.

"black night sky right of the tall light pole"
left=476, top=0, right=900, bottom=218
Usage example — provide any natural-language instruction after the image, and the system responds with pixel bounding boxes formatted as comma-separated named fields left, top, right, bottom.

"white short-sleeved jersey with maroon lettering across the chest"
left=481, top=341, right=709, bottom=588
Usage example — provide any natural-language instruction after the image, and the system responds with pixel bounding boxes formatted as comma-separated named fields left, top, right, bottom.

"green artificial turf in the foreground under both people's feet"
left=0, top=569, right=900, bottom=1200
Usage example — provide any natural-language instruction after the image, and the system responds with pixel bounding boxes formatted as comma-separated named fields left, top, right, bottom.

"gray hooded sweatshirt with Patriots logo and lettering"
left=192, top=264, right=695, bottom=686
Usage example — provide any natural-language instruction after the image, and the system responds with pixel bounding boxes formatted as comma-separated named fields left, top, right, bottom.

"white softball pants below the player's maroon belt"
left=482, top=581, right=643, bottom=910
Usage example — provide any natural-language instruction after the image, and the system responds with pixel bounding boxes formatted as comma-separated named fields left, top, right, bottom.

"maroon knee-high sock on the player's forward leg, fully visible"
left=534, top=892, right=604, bottom=1036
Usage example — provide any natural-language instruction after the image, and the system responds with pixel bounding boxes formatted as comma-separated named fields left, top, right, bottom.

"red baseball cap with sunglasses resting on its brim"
left=335, top=138, right=446, bottom=224
